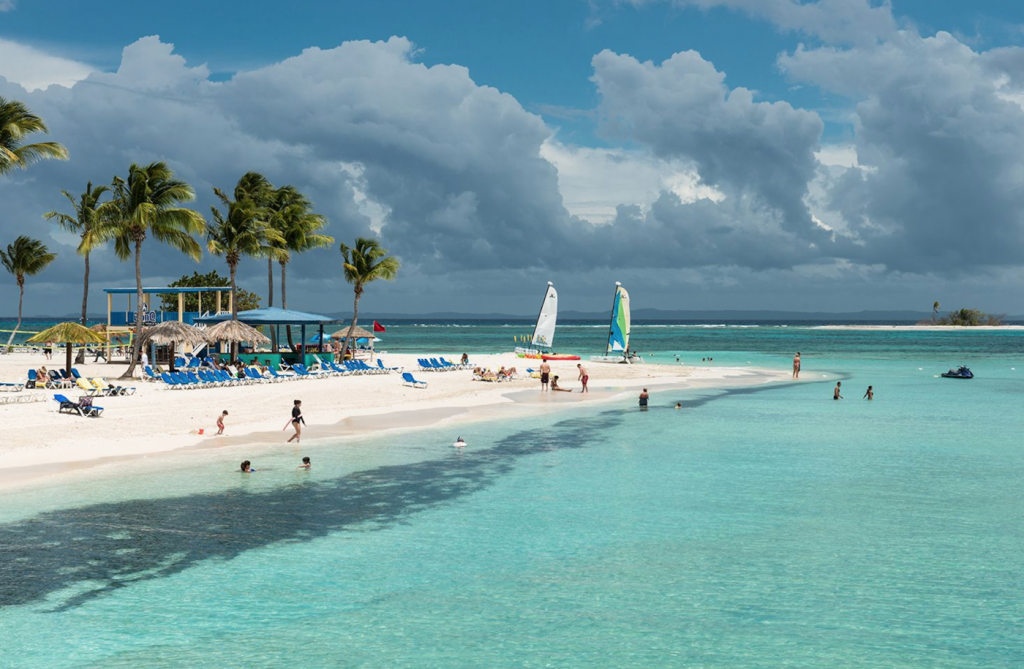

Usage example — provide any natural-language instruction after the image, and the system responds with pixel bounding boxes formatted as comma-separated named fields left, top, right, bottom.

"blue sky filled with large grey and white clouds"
left=0, top=0, right=1024, bottom=316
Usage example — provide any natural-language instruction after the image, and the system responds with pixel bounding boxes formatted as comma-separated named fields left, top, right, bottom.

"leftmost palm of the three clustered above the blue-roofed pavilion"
left=206, top=195, right=284, bottom=321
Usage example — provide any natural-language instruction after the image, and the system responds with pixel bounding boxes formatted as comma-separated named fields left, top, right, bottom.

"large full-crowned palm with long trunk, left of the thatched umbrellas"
left=98, top=162, right=206, bottom=378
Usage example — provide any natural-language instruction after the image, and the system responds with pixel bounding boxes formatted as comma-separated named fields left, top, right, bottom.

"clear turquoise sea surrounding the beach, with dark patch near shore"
left=0, top=323, right=1024, bottom=669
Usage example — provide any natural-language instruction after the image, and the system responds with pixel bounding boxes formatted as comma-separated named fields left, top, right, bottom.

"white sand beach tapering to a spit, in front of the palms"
left=0, top=353, right=788, bottom=486
